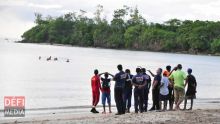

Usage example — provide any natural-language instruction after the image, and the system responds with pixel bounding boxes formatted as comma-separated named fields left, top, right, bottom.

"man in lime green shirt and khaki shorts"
left=169, top=64, right=186, bottom=110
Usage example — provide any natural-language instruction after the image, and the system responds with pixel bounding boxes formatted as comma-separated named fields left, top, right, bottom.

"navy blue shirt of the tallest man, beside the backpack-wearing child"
left=114, top=71, right=127, bottom=88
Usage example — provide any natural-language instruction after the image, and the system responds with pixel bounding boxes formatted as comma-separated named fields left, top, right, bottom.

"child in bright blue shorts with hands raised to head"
left=101, top=72, right=114, bottom=114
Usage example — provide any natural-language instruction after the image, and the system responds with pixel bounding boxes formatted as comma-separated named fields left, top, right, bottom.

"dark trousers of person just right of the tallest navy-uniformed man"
left=124, top=89, right=132, bottom=110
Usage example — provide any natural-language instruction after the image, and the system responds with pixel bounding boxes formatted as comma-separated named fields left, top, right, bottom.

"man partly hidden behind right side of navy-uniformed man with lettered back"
left=141, top=68, right=151, bottom=112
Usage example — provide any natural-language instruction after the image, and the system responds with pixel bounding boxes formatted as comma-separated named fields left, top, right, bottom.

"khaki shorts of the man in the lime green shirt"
left=174, top=87, right=185, bottom=102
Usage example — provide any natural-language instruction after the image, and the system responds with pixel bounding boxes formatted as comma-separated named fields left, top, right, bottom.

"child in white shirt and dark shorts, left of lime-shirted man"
left=160, top=73, right=170, bottom=111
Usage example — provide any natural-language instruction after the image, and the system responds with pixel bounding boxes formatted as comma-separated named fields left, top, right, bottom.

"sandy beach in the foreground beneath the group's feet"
left=0, top=107, right=220, bottom=124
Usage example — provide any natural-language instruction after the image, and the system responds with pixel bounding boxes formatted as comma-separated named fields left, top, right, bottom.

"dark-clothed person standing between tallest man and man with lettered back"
left=124, top=69, right=133, bottom=113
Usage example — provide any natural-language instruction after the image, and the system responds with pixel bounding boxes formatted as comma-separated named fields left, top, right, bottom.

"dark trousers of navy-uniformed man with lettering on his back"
left=134, top=88, right=144, bottom=112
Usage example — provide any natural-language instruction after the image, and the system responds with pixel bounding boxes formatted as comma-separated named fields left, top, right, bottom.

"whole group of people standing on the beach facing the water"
left=91, top=64, right=197, bottom=115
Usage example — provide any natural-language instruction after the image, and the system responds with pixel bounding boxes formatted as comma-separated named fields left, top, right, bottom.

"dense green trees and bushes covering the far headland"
left=21, top=5, right=220, bottom=53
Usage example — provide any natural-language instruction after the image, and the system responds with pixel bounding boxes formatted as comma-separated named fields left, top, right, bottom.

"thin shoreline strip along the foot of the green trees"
left=15, top=41, right=220, bottom=56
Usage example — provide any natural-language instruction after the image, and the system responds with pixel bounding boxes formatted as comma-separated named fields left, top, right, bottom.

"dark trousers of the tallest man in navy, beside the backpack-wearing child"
left=115, top=87, right=125, bottom=114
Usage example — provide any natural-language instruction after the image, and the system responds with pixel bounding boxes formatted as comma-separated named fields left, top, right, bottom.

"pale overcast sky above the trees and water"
left=0, top=0, right=220, bottom=39
